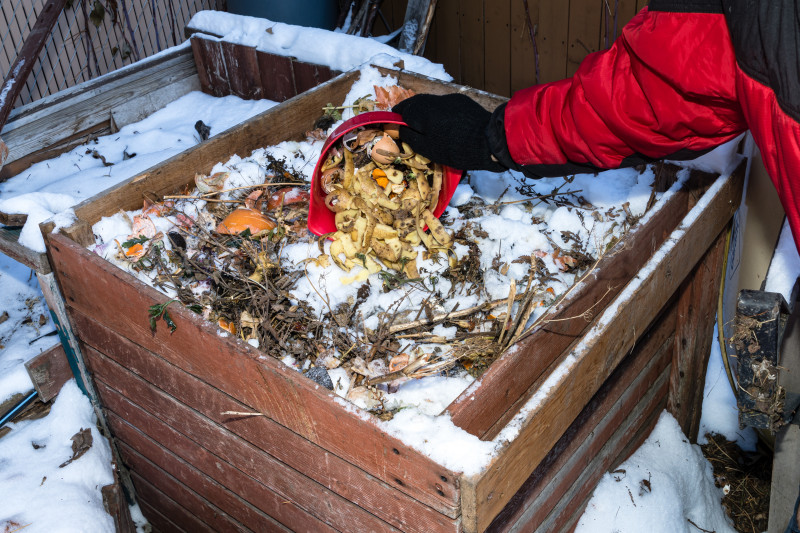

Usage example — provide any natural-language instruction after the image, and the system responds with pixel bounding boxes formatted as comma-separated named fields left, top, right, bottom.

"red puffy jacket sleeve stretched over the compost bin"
left=490, top=8, right=747, bottom=172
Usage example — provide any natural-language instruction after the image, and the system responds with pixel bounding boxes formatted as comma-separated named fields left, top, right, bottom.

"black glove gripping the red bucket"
left=392, top=93, right=506, bottom=172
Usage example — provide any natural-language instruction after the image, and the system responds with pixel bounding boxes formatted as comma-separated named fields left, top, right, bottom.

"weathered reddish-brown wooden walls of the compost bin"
left=43, top=67, right=743, bottom=532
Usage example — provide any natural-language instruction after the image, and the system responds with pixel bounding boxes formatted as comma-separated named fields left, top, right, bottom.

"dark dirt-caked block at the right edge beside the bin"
left=731, top=284, right=800, bottom=432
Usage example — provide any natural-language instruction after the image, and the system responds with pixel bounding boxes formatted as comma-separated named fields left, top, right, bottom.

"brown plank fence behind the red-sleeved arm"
left=412, top=0, right=647, bottom=96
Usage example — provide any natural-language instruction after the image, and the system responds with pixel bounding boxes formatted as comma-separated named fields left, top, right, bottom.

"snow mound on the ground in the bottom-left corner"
left=0, top=380, right=114, bottom=532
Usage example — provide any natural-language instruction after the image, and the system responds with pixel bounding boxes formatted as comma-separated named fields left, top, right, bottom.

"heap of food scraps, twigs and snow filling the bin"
left=93, top=69, right=653, bottom=417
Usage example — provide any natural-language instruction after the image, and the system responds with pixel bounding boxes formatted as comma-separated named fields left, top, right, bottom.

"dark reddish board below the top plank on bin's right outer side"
left=489, top=296, right=675, bottom=531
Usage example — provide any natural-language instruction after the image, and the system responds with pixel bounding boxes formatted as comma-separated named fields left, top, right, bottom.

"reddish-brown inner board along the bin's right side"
left=447, top=167, right=707, bottom=439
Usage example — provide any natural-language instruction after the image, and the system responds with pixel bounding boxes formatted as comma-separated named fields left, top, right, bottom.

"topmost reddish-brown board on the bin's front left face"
left=40, top=242, right=459, bottom=518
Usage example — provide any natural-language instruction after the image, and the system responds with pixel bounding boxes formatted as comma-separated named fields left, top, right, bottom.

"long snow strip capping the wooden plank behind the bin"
left=188, top=11, right=453, bottom=81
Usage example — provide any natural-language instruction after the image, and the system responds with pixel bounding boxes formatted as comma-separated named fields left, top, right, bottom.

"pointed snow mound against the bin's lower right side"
left=575, top=411, right=735, bottom=533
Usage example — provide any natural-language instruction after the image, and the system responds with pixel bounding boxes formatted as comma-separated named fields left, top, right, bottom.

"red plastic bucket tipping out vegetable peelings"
left=308, top=111, right=464, bottom=235
